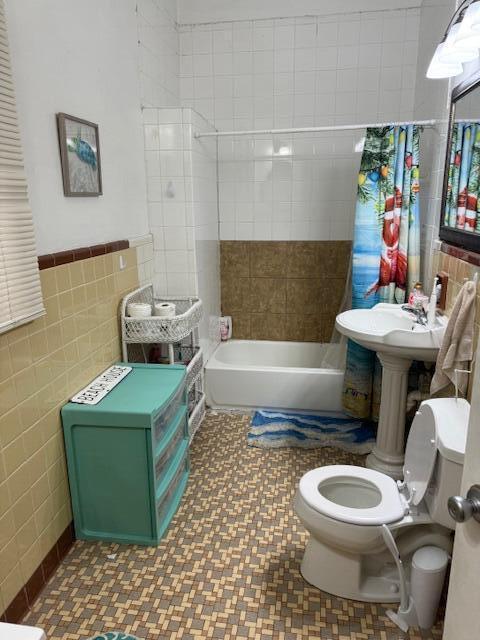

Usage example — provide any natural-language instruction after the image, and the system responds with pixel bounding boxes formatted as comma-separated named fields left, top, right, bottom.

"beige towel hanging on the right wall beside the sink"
left=430, top=281, right=477, bottom=395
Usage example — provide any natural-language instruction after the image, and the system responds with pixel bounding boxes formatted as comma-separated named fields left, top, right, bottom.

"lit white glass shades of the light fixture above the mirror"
left=427, top=0, right=480, bottom=78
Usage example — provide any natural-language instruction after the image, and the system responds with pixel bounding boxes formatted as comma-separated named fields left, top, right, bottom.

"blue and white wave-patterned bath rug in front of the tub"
left=247, top=411, right=376, bottom=454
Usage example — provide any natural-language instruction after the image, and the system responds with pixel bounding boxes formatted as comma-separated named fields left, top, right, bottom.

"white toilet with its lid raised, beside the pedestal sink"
left=294, top=398, right=470, bottom=602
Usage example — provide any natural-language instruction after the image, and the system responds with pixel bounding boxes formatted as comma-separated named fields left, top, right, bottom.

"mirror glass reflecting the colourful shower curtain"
left=444, top=122, right=480, bottom=233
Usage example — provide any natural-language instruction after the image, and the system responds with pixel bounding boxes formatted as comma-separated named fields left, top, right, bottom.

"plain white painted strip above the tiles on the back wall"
left=178, top=0, right=421, bottom=23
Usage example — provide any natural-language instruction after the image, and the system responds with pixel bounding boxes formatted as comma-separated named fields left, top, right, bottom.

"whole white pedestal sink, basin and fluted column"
left=335, top=303, right=447, bottom=479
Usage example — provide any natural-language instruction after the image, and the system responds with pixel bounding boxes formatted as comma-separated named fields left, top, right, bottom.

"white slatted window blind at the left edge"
left=0, top=0, right=44, bottom=332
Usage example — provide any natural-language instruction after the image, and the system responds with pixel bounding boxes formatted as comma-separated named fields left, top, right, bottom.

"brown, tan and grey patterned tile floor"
left=25, top=414, right=441, bottom=640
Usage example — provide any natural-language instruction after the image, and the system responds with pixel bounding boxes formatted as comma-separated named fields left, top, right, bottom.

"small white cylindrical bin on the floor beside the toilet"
left=410, top=547, right=448, bottom=629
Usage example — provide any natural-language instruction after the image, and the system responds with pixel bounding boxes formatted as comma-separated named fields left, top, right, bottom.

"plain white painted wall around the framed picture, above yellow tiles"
left=5, top=0, right=148, bottom=254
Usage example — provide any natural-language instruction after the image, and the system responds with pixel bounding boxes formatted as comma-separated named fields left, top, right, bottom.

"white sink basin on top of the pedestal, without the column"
left=335, top=303, right=447, bottom=362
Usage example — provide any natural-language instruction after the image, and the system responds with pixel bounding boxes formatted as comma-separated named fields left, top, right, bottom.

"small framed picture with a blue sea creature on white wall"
left=57, top=113, right=102, bottom=197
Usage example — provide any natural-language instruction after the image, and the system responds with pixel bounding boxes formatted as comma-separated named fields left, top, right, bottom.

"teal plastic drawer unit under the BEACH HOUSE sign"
left=62, top=363, right=189, bottom=545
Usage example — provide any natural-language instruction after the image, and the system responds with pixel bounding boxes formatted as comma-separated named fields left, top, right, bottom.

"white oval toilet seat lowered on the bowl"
left=299, top=465, right=407, bottom=525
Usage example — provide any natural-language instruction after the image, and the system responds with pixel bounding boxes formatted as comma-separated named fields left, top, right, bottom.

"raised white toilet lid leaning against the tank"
left=403, top=402, right=437, bottom=505
